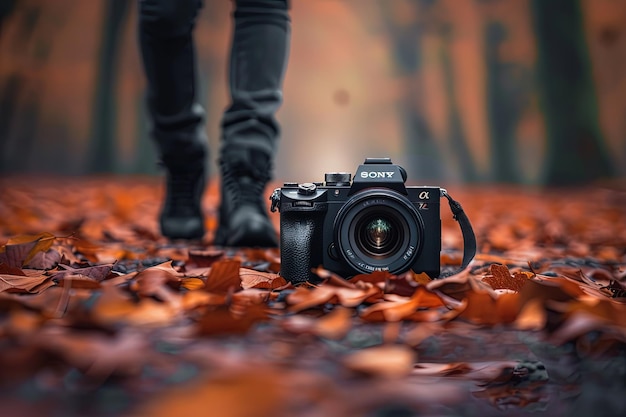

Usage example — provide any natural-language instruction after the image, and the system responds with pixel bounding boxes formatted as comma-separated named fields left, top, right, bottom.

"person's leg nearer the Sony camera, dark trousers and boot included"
left=215, top=0, right=290, bottom=247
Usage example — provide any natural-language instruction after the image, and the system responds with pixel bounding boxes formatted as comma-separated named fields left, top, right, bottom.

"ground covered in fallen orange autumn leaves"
left=0, top=178, right=626, bottom=417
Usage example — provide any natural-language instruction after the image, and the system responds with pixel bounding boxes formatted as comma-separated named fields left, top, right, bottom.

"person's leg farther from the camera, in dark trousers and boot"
left=139, top=0, right=207, bottom=239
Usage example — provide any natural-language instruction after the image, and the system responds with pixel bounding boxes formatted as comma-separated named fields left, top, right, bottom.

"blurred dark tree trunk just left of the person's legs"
left=87, top=0, right=131, bottom=173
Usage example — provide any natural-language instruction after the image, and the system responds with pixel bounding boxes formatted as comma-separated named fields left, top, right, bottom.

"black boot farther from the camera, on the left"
left=159, top=167, right=205, bottom=240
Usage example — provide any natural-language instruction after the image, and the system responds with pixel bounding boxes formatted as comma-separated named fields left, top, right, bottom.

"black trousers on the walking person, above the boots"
left=139, top=0, right=290, bottom=167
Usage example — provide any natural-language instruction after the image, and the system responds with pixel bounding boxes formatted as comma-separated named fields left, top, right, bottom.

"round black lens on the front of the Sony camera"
left=334, top=188, right=424, bottom=273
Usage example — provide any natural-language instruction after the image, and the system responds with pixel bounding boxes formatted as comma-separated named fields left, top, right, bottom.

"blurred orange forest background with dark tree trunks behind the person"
left=0, top=0, right=626, bottom=185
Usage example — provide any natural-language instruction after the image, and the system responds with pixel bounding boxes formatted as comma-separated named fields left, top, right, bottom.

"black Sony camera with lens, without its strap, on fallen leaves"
left=271, top=158, right=445, bottom=283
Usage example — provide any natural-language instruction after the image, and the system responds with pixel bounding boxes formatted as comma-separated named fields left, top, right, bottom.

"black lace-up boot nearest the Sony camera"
left=215, top=153, right=278, bottom=248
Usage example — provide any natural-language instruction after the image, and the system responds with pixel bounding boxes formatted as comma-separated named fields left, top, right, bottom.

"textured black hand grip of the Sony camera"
left=280, top=211, right=323, bottom=284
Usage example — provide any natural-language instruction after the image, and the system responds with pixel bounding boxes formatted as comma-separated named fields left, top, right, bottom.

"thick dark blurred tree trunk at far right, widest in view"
left=532, top=0, right=613, bottom=185
